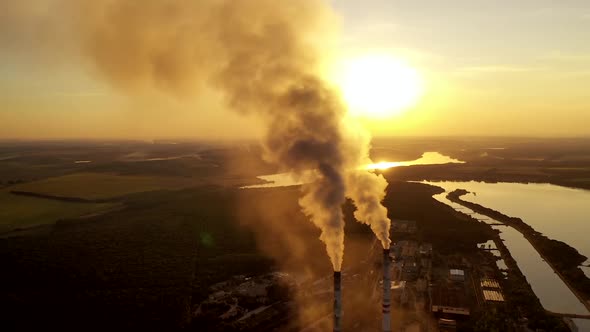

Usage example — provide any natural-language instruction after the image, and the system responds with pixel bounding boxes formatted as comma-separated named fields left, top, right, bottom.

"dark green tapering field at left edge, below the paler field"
left=0, top=190, right=116, bottom=233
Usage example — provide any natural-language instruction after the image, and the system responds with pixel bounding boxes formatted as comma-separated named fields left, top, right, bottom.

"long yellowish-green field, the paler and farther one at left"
left=10, top=173, right=201, bottom=200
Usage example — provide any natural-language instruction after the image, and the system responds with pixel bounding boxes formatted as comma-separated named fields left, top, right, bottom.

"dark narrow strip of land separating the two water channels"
left=447, top=189, right=590, bottom=311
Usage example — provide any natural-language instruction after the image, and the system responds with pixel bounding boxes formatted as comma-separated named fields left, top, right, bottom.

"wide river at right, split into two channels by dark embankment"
left=424, top=181, right=590, bottom=331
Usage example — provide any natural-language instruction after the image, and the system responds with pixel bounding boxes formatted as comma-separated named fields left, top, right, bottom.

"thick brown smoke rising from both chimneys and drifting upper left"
left=0, top=0, right=389, bottom=271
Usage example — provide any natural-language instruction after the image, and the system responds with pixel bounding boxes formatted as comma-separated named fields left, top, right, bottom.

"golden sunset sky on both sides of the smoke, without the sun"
left=0, top=0, right=590, bottom=139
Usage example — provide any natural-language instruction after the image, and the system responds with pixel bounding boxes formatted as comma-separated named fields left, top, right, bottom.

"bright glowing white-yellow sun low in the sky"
left=336, top=55, right=424, bottom=119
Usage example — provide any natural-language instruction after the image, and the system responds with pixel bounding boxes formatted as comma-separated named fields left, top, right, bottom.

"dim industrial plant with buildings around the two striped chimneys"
left=193, top=213, right=520, bottom=332
